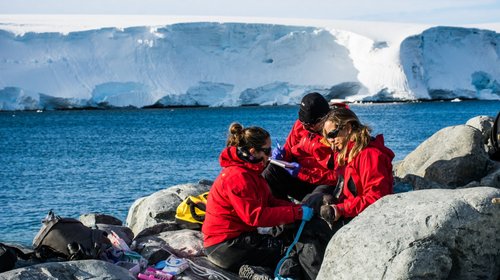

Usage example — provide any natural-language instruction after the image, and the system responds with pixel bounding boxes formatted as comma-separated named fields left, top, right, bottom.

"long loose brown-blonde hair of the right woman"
left=323, top=107, right=371, bottom=166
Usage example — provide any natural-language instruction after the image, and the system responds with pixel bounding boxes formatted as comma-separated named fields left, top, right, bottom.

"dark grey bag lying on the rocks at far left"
left=33, top=211, right=112, bottom=260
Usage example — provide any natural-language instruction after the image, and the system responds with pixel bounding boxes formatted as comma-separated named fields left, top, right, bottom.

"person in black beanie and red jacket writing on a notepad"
left=262, top=92, right=337, bottom=201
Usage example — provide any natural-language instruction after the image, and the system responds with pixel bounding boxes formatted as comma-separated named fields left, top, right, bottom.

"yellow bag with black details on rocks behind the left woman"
left=175, top=192, right=208, bottom=230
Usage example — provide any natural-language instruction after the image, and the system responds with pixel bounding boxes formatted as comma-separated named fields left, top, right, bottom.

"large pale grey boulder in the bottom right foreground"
left=317, top=187, right=500, bottom=279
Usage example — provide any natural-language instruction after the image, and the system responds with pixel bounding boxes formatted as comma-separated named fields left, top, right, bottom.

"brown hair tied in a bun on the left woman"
left=226, top=122, right=271, bottom=150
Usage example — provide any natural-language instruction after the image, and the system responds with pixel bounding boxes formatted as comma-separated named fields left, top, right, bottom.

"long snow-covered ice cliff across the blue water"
left=0, top=17, right=500, bottom=110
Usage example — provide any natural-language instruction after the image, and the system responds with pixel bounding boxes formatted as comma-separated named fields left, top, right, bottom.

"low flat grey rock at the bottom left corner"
left=0, top=260, right=135, bottom=280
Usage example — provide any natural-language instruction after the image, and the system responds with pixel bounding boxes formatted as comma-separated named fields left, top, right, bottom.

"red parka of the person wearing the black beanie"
left=283, top=120, right=337, bottom=185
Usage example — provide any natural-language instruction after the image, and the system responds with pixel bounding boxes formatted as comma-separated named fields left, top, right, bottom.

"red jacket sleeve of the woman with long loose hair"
left=337, top=149, right=393, bottom=217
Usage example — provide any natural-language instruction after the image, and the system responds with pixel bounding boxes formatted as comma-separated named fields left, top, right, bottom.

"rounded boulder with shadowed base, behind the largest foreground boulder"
left=394, top=125, right=492, bottom=189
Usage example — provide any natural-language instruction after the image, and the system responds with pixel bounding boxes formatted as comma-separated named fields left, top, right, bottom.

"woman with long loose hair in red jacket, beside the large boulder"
left=320, top=108, right=394, bottom=223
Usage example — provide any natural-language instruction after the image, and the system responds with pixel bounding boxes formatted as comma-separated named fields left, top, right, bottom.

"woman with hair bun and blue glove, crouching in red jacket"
left=202, top=123, right=313, bottom=279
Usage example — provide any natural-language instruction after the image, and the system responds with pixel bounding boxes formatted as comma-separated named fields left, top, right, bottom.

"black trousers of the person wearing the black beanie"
left=262, top=164, right=317, bottom=201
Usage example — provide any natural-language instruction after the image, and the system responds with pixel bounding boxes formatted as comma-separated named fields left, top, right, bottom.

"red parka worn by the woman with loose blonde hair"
left=336, top=135, right=394, bottom=217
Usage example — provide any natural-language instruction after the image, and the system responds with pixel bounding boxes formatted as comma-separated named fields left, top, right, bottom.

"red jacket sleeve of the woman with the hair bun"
left=228, top=174, right=302, bottom=227
